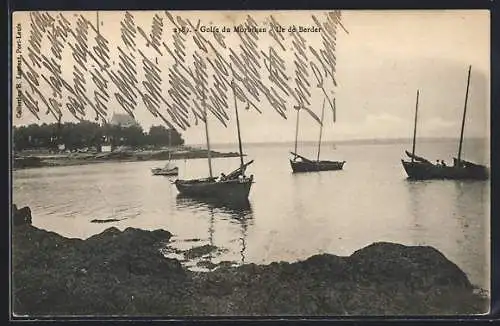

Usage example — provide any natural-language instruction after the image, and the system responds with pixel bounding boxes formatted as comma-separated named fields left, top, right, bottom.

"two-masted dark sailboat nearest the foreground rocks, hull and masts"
left=174, top=81, right=253, bottom=202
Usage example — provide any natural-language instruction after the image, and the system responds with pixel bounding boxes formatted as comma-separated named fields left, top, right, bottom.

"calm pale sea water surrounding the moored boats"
left=13, top=141, right=490, bottom=289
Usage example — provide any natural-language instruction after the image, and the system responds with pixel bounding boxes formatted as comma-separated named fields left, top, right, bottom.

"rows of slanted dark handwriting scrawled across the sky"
left=14, top=11, right=347, bottom=129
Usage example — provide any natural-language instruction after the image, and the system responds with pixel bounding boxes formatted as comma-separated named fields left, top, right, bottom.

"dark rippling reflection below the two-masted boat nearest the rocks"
left=176, top=194, right=253, bottom=269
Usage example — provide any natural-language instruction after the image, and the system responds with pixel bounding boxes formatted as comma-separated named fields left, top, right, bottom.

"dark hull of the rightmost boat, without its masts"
left=401, top=160, right=488, bottom=180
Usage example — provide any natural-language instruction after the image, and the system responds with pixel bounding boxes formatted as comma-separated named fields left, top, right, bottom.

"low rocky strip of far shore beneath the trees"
left=12, top=147, right=243, bottom=169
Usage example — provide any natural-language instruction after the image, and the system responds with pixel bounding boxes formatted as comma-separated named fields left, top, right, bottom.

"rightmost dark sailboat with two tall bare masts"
left=401, top=66, right=488, bottom=180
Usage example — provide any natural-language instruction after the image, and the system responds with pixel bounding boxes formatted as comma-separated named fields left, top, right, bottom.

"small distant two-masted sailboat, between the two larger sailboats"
left=290, top=99, right=345, bottom=173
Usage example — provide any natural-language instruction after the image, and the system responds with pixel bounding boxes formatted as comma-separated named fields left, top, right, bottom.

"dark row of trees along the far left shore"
left=12, top=121, right=184, bottom=152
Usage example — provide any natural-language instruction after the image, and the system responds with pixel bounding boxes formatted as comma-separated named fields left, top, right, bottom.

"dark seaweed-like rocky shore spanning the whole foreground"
left=12, top=206, right=489, bottom=316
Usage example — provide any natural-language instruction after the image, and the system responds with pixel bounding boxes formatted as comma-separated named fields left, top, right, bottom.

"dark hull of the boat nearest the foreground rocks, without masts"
left=175, top=178, right=253, bottom=202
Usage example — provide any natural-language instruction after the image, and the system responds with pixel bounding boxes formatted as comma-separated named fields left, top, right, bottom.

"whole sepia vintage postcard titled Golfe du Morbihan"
left=10, top=9, right=490, bottom=318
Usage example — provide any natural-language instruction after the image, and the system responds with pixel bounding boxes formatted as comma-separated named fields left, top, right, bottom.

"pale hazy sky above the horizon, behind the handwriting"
left=13, top=10, right=490, bottom=144
